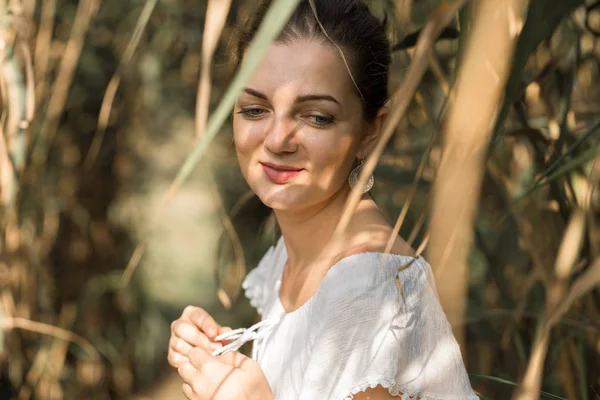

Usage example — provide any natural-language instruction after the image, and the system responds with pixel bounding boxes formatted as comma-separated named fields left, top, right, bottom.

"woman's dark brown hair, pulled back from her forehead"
left=235, top=0, right=391, bottom=120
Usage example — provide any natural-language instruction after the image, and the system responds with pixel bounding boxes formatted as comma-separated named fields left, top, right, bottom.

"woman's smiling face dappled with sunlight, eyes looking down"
left=233, top=40, right=368, bottom=210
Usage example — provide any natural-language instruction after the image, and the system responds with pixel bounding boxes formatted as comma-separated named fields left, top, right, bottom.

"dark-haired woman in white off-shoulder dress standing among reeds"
left=169, top=0, right=477, bottom=400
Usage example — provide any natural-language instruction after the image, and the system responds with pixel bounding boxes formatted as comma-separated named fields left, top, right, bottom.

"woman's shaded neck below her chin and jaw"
left=275, top=184, right=358, bottom=270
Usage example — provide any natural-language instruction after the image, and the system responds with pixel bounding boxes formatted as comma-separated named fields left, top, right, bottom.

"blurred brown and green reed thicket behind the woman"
left=0, top=0, right=600, bottom=400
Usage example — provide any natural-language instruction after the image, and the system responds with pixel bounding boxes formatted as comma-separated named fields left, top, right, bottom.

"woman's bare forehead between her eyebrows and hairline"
left=248, top=40, right=354, bottom=101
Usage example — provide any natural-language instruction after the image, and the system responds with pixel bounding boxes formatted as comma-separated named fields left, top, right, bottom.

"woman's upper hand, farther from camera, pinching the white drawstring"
left=167, top=306, right=231, bottom=368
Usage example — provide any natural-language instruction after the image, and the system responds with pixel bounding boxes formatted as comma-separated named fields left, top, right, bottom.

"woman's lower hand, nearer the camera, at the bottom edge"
left=177, top=347, right=274, bottom=400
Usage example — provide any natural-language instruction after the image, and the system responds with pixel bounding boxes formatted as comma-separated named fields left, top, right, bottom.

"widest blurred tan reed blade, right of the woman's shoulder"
left=428, top=0, right=527, bottom=349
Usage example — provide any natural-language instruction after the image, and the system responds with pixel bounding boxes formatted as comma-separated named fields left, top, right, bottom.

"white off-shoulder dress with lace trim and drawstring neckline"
left=240, top=239, right=478, bottom=400
